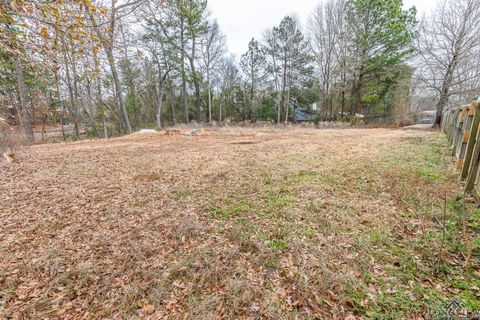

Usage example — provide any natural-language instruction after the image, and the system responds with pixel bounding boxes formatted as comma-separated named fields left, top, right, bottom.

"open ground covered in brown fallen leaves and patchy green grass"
left=0, top=128, right=480, bottom=319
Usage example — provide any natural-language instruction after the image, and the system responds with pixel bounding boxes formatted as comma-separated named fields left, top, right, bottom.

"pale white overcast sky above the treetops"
left=208, top=0, right=438, bottom=58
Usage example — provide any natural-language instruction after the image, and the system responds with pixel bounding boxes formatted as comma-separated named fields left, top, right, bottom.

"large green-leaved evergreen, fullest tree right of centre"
left=347, top=0, right=416, bottom=112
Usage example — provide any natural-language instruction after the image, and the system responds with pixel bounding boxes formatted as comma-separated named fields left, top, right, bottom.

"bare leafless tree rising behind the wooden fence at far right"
left=417, top=0, right=480, bottom=126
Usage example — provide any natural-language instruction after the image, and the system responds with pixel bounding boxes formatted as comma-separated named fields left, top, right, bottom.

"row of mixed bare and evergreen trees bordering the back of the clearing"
left=0, top=0, right=480, bottom=139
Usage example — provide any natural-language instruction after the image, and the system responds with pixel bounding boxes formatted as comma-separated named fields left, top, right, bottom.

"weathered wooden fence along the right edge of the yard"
left=441, top=102, right=480, bottom=203
